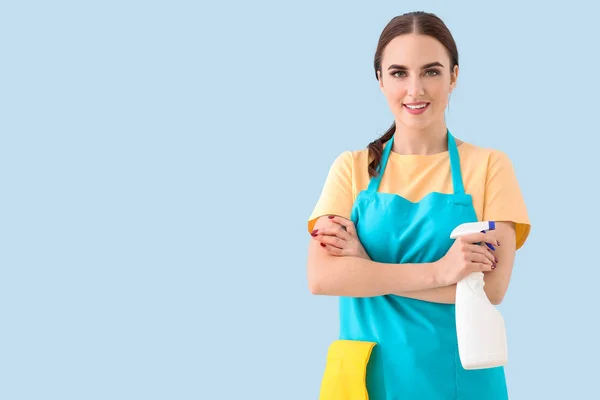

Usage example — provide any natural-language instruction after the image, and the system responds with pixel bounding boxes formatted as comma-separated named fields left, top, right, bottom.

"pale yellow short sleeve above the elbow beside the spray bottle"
left=483, top=152, right=531, bottom=249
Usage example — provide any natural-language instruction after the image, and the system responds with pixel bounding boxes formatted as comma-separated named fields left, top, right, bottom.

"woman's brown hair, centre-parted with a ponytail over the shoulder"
left=368, top=11, right=458, bottom=176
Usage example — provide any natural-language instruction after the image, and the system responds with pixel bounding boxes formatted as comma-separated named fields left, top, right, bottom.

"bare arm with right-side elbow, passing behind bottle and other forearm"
left=394, top=222, right=516, bottom=305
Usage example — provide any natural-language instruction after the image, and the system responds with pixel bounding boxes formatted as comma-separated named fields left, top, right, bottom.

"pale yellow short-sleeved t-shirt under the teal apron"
left=308, top=142, right=531, bottom=249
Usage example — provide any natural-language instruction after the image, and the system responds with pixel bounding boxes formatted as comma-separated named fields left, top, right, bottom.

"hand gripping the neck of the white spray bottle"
left=434, top=231, right=500, bottom=286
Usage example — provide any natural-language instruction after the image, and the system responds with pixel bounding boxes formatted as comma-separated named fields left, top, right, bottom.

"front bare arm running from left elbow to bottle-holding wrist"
left=307, top=216, right=439, bottom=297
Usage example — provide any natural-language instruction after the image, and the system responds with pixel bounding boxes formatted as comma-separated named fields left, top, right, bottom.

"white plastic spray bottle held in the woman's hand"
left=450, top=221, right=508, bottom=369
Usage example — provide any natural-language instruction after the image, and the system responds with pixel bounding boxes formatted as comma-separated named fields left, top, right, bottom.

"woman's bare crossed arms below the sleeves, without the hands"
left=307, top=216, right=516, bottom=305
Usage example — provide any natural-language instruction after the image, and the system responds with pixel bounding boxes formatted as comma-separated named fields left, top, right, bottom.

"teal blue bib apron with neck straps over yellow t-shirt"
left=339, top=131, right=508, bottom=400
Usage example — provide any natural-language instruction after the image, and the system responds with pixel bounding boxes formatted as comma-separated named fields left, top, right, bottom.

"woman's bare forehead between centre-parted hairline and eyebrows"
left=382, top=33, right=449, bottom=69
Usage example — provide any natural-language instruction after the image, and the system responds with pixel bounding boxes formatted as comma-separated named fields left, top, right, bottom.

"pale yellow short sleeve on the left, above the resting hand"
left=308, top=151, right=354, bottom=232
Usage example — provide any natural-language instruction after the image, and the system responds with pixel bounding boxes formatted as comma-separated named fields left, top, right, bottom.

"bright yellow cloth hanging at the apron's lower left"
left=319, top=340, right=376, bottom=400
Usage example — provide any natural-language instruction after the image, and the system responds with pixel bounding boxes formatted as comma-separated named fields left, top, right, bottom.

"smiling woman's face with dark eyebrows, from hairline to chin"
left=378, top=34, right=458, bottom=129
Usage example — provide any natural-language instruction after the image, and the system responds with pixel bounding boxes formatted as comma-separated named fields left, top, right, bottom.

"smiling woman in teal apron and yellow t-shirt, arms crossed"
left=307, top=12, right=530, bottom=400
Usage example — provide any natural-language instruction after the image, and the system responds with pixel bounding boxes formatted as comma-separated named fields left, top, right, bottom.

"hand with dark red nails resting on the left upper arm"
left=311, top=215, right=370, bottom=260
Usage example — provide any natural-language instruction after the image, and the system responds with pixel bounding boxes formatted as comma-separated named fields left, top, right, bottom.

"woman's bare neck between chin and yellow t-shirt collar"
left=392, top=121, right=448, bottom=155
